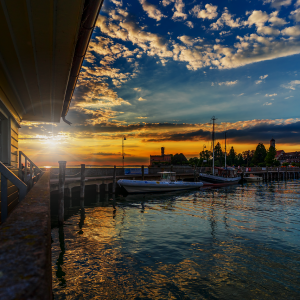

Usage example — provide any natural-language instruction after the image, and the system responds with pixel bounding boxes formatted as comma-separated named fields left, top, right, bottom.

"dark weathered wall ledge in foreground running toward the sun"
left=0, top=172, right=52, bottom=300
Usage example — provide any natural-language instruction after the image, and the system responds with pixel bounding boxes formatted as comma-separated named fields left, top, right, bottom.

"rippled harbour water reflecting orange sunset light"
left=52, top=180, right=300, bottom=299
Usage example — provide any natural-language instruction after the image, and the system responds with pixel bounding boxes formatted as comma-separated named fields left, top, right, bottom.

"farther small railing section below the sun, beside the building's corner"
left=19, top=151, right=43, bottom=189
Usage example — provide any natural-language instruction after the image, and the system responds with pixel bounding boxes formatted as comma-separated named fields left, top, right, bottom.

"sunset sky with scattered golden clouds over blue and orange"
left=19, top=0, right=300, bottom=166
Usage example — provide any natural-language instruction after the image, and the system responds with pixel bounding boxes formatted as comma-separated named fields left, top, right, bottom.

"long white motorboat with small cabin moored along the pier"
left=118, top=172, right=203, bottom=193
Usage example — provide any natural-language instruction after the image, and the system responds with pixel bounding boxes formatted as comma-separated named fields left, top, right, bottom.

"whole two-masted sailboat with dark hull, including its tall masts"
left=199, top=117, right=241, bottom=185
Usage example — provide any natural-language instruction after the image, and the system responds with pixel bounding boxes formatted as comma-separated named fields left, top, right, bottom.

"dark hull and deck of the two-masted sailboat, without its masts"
left=199, top=167, right=241, bottom=184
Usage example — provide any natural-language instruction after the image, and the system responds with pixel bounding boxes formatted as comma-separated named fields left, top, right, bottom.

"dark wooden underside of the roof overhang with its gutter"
left=0, top=0, right=103, bottom=122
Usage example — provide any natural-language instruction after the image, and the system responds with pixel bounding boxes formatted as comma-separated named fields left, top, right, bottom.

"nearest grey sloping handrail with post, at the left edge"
left=0, top=162, right=27, bottom=223
